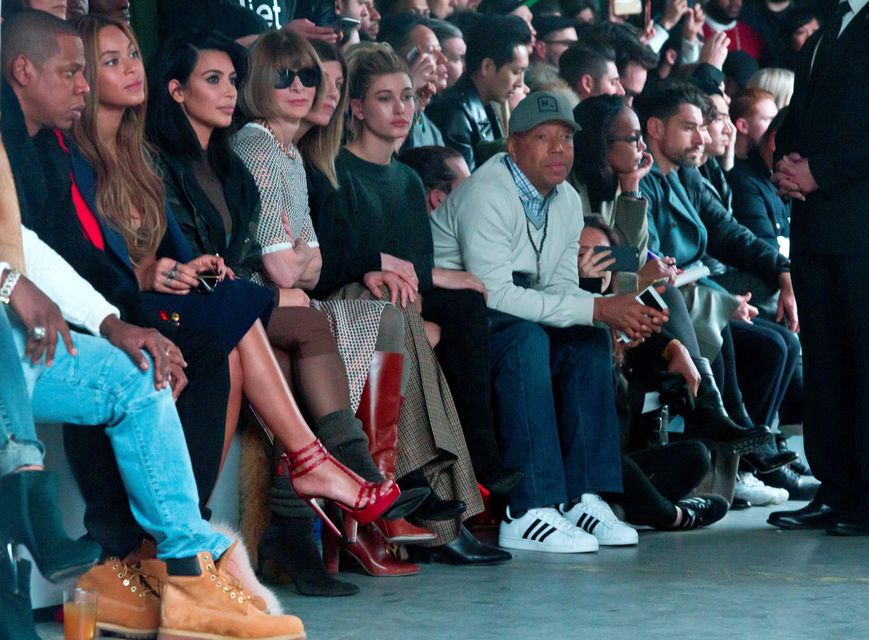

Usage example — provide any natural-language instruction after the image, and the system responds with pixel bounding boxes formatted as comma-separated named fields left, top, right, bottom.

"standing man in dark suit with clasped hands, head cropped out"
left=769, top=0, right=869, bottom=535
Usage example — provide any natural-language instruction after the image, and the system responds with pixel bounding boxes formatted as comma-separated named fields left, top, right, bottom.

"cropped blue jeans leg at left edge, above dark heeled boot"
left=0, top=304, right=44, bottom=475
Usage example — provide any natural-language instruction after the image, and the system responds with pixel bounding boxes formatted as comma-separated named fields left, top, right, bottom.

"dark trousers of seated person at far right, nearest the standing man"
left=730, top=318, right=800, bottom=425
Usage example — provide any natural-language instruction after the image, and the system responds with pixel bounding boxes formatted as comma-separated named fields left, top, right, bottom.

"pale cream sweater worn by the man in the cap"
left=431, top=153, right=594, bottom=327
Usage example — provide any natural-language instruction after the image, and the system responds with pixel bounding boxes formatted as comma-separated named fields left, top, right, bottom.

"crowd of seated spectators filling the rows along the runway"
left=0, top=0, right=840, bottom=640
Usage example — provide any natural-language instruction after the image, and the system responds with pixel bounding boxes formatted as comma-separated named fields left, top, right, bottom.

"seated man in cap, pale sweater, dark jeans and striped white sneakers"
left=431, top=91, right=666, bottom=553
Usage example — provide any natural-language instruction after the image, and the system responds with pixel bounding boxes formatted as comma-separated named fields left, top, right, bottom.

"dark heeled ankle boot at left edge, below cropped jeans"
left=0, top=471, right=101, bottom=582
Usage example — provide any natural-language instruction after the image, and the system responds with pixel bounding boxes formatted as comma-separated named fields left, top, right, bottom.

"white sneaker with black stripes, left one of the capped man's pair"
left=498, top=507, right=598, bottom=553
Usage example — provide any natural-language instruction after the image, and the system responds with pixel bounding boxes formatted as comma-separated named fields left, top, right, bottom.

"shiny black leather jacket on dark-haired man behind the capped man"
left=425, top=74, right=503, bottom=171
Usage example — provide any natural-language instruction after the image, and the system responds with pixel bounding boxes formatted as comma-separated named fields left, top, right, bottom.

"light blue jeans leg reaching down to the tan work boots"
left=3, top=306, right=230, bottom=559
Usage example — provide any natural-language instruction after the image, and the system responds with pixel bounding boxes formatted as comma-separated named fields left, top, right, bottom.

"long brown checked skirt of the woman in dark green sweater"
left=333, top=284, right=483, bottom=546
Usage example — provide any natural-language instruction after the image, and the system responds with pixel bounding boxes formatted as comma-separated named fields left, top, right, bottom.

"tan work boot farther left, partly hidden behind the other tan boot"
left=77, top=558, right=160, bottom=638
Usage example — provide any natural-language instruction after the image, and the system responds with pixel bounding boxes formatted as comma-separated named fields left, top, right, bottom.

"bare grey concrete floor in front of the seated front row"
left=40, top=502, right=869, bottom=640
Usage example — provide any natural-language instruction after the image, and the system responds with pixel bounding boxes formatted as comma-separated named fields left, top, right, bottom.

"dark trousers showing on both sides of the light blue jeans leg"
left=63, top=329, right=229, bottom=557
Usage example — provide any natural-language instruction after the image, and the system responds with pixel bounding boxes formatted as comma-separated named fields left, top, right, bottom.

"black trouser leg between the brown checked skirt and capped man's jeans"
left=422, top=289, right=501, bottom=484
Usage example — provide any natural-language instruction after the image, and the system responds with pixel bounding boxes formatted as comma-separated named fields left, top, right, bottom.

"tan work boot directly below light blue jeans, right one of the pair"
left=160, top=548, right=306, bottom=640
